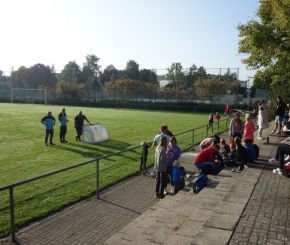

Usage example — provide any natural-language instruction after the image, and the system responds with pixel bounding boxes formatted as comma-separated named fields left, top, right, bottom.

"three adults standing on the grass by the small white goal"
left=40, top=108, right=90, bottom=145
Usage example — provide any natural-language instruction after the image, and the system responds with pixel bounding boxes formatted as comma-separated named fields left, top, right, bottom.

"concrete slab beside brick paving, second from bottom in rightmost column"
left=205, top=213, right=240, bottom=231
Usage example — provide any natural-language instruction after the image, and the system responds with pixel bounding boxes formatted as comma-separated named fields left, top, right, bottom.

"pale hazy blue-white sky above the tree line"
left=0, top=0, right=259, bottom=80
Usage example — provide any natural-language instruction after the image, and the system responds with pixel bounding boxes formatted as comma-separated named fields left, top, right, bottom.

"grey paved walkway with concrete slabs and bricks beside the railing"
left=0, top=123, right=290, bottom=245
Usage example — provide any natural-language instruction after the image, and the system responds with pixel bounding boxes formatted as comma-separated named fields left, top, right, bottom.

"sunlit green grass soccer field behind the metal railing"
left=0, top=104, right=227, bottom=236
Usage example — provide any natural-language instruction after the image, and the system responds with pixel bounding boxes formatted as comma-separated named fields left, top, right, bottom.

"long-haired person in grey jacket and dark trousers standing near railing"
left=154, top=137, right=167, bottom=199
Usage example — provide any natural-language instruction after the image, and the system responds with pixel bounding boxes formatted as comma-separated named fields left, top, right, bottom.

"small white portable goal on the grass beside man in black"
left=82, top=124, right=110, bottom=144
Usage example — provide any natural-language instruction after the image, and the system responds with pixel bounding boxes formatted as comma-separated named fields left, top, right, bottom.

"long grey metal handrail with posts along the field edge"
left=0, top=118, right=228, bottom=242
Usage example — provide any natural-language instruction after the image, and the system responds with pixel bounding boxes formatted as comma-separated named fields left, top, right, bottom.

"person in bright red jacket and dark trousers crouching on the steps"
left=195, top=141, right=221, bottom=175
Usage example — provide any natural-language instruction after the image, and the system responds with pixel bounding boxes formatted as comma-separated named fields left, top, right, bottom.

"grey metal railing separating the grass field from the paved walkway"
left=0, top=119, right=228, bottom=242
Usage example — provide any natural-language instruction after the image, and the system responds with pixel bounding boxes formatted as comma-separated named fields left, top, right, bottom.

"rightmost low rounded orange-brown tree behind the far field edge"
left=195, top=77, right=225, bottom=103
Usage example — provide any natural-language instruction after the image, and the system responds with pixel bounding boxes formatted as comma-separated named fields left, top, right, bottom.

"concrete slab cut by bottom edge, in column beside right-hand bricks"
left=191, top=227, right=232, bottom=245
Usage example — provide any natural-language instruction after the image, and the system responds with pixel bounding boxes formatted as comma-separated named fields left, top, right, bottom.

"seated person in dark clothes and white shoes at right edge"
left=269, top=137, right=290, bottom=175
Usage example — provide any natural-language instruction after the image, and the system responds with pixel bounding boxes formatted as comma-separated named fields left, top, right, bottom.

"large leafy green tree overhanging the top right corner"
left=238, top=0, right=290, bottom=95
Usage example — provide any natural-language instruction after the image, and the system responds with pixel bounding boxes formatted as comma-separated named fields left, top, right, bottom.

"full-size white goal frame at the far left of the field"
left=10, top=88, right=47, bottom=105
